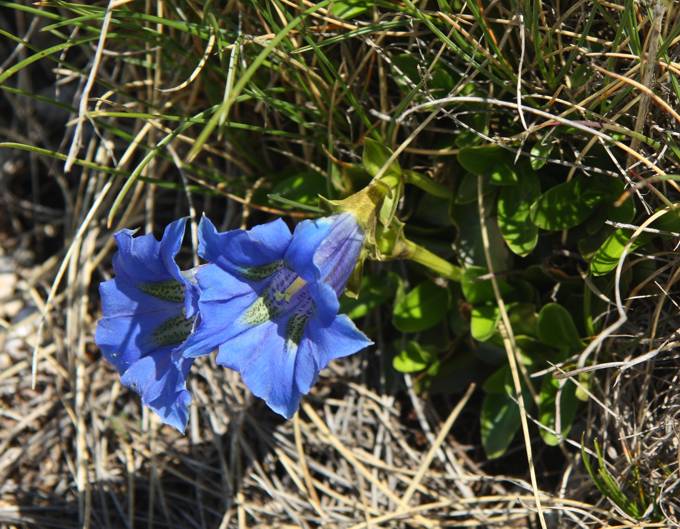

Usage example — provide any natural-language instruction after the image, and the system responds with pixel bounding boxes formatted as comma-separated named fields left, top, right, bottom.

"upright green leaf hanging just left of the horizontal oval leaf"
left=497, top=170, right=541, bottom=257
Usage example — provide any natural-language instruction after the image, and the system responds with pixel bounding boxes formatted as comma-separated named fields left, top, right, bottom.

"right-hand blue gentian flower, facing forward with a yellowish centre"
left=185, top=213, right=372, bottom=418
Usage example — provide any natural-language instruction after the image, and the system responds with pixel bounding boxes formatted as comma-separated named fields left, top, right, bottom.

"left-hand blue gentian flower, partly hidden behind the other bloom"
left=95, top=219, right=198, bottom=432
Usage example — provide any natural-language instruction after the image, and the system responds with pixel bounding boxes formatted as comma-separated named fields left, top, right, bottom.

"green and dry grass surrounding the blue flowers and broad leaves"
left=0, top=0, right=680, bottom=528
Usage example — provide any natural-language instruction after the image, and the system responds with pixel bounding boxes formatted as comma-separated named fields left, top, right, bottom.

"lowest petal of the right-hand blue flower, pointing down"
left=217, top=322, right=301, bottom=419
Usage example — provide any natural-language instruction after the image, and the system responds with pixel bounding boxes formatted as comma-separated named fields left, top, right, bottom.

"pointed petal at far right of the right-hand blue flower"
left=305, top=314, right=373, bottom=369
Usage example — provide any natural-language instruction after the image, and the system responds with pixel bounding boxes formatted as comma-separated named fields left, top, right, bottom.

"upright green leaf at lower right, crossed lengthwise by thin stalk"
left=538, top=375, right=578, bottom=446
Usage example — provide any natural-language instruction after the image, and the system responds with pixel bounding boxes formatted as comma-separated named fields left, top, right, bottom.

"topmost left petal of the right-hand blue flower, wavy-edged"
left=198, top=217, right=291, bottom=272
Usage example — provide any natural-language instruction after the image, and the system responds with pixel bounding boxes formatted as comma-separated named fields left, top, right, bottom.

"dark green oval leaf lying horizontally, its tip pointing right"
left=530, top=178, right=606, bottom=231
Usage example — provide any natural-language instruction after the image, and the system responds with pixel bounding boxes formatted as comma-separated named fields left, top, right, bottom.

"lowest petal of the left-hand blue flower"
left=121, top=347, right=193, bottom=433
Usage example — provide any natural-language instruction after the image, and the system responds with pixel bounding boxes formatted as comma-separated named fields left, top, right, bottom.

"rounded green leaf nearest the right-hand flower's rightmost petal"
left=392, top=281, right=449, bottom=332
